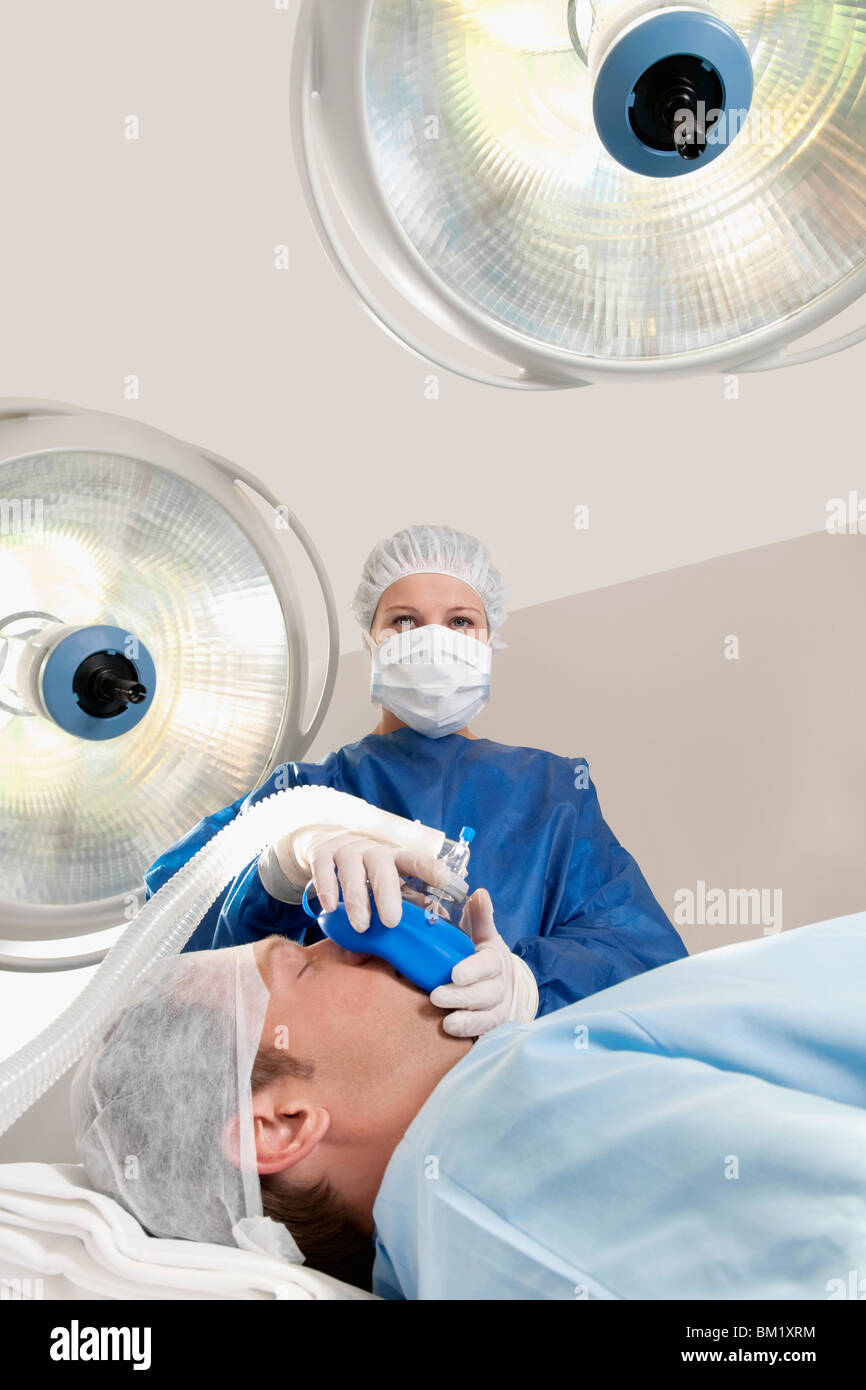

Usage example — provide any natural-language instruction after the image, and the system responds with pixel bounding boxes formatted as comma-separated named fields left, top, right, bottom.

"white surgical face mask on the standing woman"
left=364, top=624, right=492, bottom=738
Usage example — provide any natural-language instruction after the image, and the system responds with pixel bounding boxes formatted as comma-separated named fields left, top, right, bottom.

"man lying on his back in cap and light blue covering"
left=74, top=891, right=866, bottom=1300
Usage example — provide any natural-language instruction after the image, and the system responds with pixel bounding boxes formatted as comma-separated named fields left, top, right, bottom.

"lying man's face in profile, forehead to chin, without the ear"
left=250, top=935, right=471, bottom=1106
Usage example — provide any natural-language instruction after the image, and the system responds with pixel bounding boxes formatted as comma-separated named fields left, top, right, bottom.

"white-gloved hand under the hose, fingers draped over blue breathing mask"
left=272, top=826, right=461, bottom=931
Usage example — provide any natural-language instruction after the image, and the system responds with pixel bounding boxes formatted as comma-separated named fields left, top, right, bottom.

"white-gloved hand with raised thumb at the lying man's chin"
left=430, top=888, right=538, bottom=1038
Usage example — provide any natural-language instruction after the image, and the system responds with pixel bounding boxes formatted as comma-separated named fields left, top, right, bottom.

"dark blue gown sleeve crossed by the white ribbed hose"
left=145, top=766, right=321, bottom=951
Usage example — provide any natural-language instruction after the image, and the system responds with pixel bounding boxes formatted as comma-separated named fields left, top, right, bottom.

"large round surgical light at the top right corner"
left=292, top=0, right=866, bottom=388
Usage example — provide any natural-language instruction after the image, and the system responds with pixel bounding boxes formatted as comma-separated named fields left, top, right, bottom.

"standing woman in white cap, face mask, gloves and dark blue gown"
left=145, top=525, right=687, bottom=1037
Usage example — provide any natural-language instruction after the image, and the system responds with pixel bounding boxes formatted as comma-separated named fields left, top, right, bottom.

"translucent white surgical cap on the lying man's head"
left=71, top=947, right=303, bottom=1264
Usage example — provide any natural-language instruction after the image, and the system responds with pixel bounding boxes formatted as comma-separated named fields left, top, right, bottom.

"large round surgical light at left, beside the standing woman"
left=0, top=400, right=339, bottom=970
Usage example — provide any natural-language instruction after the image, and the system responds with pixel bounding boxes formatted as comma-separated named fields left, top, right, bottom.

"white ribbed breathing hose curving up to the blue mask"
left=0, top=787, right=445, bottom=1134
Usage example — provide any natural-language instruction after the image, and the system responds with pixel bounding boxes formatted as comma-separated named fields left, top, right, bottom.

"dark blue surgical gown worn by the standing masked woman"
left=145, top=728, right=687, bottom=1015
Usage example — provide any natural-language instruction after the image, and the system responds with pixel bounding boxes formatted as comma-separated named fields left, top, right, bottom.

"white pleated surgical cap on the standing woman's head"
left=352, top=525, right=510, bottom=632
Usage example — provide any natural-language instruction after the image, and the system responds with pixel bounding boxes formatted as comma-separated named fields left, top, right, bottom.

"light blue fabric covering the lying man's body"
left=373, top=913, right=866, bottom=1300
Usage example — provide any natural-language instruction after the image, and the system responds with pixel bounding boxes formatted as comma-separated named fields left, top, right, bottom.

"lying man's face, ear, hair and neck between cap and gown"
left=244, top=917, right=473, bottom=1287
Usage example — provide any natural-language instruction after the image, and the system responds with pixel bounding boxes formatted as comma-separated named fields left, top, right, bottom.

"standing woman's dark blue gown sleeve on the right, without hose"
left=511, top=778, right=688, bottom=1017
